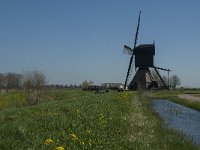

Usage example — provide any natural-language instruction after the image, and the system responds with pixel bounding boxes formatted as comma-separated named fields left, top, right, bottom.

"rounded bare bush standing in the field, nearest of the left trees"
left=22, top=70, right=47, bottom=105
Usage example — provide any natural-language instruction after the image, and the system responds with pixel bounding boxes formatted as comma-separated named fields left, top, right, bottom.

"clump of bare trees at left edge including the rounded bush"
left=0, top=70, right=47, bottom=105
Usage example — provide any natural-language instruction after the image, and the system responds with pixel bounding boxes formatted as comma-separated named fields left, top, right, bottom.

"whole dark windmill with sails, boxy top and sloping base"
left=124, top=11, right=171, bottom=90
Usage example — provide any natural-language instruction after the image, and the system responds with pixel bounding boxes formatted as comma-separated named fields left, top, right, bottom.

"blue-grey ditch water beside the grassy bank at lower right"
left=152, top=99, right=200, bottom=146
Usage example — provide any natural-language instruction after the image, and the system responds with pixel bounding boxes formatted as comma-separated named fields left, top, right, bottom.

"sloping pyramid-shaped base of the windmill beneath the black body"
left=128, top=67, right=158, bottom=90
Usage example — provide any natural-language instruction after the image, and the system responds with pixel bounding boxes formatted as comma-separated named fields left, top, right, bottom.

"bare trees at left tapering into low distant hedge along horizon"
left=0, top=70, right=84, bottom=91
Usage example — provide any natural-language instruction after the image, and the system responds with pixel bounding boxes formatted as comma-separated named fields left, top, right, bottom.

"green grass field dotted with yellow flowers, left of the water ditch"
left=0, top=90, right=197, bottom=150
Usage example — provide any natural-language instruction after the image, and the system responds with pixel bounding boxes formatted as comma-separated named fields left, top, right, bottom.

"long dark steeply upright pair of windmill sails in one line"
left=124, top=11, right=141, bottom=89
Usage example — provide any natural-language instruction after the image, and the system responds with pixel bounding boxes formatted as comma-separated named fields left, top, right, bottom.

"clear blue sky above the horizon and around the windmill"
left=0, top=0, right=200, bottom=87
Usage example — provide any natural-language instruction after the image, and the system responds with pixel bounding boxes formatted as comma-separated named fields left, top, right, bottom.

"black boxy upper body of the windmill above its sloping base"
left=134, top=44, right=155, bottom=67
